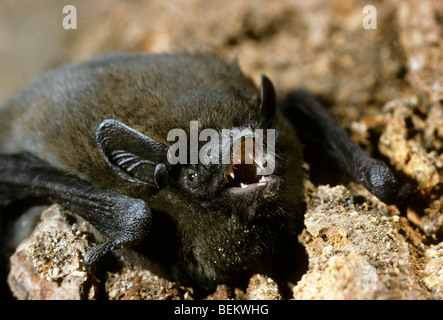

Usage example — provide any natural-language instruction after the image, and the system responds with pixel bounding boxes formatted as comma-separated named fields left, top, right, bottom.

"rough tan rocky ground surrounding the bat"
left=0, top=0, right=443, bottom=299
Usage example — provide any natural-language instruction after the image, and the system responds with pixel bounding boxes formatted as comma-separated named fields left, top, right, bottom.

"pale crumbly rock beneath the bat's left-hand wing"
left=8, top=205, right=97, bottom=300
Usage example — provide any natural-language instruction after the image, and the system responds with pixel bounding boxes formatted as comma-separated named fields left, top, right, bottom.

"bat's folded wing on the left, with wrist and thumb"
left=0, top=153, right=151, bottom=267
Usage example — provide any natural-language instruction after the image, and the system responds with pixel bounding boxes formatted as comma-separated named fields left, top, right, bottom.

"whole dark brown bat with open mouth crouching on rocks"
left=0, top=53, right=399, bottom=296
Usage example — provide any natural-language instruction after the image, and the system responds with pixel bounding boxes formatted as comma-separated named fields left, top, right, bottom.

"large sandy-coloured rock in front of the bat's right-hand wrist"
left=293, top=186, right=431, bottom=300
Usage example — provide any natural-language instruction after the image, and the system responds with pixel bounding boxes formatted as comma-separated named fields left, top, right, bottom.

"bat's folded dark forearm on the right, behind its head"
left=281, top=90, right=399, bottom=204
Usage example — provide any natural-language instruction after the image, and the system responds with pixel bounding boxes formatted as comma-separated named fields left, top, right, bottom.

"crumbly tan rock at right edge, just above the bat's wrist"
left=379, top=98, right=443, bottom=198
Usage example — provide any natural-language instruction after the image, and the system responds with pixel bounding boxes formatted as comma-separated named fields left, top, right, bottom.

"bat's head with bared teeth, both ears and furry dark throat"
left=96, top=76, right=302, bottom=286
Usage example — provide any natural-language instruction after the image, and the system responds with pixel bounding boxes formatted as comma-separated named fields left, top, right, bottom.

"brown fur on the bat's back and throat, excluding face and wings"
left=0, top=54, right=303, bottom=288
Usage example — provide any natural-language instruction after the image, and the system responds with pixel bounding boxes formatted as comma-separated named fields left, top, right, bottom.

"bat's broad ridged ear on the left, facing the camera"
left=95, top=119, right=170, bottom=188
